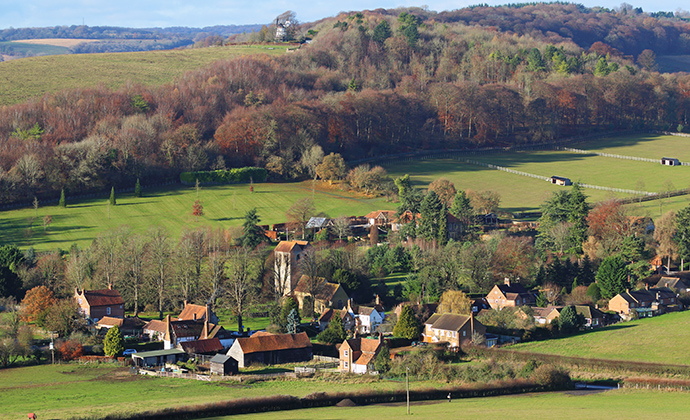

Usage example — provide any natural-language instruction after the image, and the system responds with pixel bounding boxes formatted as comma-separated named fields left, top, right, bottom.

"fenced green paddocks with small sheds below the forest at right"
left=386, top=135, right=690, bottom=216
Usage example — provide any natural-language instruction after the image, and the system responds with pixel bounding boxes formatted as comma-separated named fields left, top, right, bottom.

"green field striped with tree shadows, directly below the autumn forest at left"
left=0, top=182, right=395, bottom=250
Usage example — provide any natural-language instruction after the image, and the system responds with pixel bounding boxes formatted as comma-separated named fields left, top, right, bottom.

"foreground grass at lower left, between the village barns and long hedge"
left=0, top=364, right=442, bottom=419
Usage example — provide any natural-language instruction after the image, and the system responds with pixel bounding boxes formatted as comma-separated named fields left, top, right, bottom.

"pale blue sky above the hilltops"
left=0, top=0, right=689, bottom=29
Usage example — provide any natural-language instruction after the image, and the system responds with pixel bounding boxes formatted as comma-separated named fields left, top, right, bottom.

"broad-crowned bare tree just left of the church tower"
left=225, top=247, right=261, bottom=331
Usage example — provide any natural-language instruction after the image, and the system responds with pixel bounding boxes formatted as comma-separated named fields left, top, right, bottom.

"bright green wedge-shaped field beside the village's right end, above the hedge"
left=509, top=311, right=690, bottom=365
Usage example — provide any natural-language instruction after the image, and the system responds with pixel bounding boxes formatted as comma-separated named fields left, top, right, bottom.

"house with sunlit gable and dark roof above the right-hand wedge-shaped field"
left=609, top=287, right=677, bottom=318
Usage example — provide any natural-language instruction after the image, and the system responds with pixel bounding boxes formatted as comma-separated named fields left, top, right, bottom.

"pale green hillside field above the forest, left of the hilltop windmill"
left=0, top=44, right=285, bottom=105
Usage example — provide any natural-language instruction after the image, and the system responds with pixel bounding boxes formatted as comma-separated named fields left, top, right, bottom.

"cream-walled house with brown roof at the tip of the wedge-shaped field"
left=422, top=314, right=486, bottom=348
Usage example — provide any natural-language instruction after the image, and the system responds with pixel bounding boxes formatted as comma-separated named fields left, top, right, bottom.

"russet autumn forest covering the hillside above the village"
left=0, top=3, right=690, bottom=203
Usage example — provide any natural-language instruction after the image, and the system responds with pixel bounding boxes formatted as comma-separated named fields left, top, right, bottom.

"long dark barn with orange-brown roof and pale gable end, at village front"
left=226, top=332, right=313, bottom=368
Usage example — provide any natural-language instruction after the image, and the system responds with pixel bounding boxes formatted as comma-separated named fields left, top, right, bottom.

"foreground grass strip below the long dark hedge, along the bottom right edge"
left=214, top=390, right=688, bottom=420
